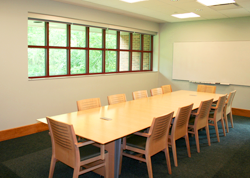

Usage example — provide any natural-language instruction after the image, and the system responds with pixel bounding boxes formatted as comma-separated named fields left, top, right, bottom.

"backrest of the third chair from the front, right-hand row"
left=194, top=99, right=213, bottom=129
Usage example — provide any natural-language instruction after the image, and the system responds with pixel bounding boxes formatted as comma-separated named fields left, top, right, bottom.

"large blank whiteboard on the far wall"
left=172, top=41, right=250, bottom=86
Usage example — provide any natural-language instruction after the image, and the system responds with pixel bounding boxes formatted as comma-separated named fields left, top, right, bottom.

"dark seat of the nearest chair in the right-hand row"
left=127, top=135, right=147, bottom=150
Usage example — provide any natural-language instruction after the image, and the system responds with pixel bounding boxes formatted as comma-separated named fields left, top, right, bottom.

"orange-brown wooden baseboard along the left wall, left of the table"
left=0, top=123, right=49, bottom=141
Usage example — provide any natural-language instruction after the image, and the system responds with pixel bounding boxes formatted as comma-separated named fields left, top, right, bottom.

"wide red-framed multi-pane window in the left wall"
left=28, top=19, right=153, bottom=78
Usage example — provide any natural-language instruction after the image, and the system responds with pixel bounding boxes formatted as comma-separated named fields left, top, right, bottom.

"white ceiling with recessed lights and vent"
left=54, top=0, right=250, bottom=23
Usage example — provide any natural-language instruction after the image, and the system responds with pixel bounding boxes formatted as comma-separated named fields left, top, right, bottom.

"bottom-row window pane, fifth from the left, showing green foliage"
left=105, top=51, right=117, bottom=72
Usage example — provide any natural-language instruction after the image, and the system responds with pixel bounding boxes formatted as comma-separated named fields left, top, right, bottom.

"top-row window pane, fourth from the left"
left=89, top=27, right=102, bottom=48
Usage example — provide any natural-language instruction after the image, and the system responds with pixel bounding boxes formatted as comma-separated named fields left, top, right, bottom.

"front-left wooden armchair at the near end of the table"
left=47, top=117, right=109, bottom=178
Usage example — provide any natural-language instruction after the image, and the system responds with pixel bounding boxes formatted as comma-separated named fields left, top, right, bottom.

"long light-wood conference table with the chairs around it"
left=38, top=90, right=225, bottom=178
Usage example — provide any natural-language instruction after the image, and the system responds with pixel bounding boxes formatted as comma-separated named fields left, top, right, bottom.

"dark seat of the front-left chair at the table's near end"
left=79, top=145, right=107, bottom=161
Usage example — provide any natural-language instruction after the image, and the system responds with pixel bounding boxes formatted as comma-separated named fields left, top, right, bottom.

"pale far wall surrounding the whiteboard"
left=159, top=17, right=250, bottom=109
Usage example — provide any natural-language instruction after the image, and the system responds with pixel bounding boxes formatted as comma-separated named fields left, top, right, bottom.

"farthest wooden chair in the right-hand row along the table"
left=224, top=90, right=236, bottom=132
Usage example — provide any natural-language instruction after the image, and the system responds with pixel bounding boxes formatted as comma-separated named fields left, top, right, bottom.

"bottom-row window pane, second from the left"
left=49, top=49, right=67, bottom=75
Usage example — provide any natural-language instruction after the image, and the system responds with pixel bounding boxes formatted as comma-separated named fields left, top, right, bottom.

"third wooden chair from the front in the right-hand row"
left=188, top=99, right=213, bottom=153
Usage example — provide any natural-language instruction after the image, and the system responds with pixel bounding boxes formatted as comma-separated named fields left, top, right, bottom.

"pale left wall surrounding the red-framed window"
left=0, top=0, right=159, bottom=130
